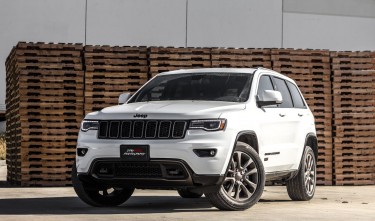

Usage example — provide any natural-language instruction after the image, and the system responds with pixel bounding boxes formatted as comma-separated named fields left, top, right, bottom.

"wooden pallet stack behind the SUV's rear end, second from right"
left=271, top=49, right=333, bottom=185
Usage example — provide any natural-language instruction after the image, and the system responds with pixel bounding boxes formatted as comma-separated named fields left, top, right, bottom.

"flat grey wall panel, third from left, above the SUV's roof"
left=187, top=0, right=282, bottom=48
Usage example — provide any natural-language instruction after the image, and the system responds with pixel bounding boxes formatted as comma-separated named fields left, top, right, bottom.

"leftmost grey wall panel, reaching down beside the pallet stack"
left=0, top=0, right=85, bottom=104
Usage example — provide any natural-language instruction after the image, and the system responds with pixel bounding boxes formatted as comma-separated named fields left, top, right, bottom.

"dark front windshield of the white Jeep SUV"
left=128, top=73, right=253, bottom=103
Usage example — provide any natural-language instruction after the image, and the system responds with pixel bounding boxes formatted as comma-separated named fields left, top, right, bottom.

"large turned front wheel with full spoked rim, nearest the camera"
left=205, top=141, right=265, bottom=210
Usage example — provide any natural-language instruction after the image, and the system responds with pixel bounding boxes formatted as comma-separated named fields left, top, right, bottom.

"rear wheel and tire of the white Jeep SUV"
left=286, top=146, right=316, bottom=201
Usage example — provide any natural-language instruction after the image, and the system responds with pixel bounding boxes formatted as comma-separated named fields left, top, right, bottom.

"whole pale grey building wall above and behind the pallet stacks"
left=0, top=0, right=375, bottom=107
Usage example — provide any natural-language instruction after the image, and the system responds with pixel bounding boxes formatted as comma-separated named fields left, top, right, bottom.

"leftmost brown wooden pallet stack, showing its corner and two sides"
left=6, top=42, right=84, bottom=186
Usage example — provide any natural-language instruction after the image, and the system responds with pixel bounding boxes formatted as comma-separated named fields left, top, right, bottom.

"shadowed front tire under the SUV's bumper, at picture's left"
left=72, top=162, right=134, bottom=207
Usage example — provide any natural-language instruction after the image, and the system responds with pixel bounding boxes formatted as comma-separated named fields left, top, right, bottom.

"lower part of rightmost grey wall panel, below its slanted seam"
left=283, top=13, right=375, bottom=50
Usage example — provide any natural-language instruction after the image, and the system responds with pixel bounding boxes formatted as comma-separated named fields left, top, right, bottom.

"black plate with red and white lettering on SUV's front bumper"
left=120, top=145, right=150, bottom=161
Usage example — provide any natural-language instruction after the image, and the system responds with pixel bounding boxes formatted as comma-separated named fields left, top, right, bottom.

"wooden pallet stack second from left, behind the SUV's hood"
left=84, top=46, right=148, bottom=114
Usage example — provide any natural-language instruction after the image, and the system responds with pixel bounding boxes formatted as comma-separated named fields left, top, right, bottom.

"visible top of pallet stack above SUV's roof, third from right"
left=211, top=48, right=272, bottom=68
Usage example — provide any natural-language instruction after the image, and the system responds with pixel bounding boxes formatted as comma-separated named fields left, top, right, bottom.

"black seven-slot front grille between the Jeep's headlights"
left=98, top=120, right=188, bottom=139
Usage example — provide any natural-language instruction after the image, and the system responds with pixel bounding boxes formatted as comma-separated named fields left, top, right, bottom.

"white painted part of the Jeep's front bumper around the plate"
left=77, top=129, right=236, bottom=176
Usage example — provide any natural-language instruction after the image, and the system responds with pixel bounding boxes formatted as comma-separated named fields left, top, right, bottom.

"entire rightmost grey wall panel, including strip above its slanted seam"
left=283, top=0, right=375, bottom=51
